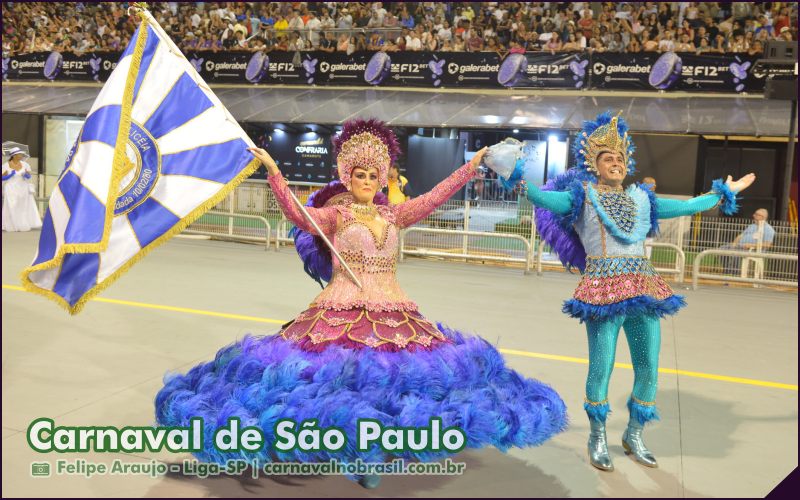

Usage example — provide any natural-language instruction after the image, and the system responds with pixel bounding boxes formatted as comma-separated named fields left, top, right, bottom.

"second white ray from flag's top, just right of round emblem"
left=157, top=108, right=242, bottom=155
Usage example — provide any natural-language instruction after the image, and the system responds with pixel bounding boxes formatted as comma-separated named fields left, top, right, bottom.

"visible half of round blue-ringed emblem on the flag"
left=114, top=120, right=161, bottom=216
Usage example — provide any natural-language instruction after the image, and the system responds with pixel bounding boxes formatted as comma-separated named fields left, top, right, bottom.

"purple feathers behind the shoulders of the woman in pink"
left=289, top=180, right=389, bottom=287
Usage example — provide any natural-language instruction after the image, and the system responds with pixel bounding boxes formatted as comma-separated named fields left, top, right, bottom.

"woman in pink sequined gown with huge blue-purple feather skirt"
left=156, top=120, right=567, bottom=488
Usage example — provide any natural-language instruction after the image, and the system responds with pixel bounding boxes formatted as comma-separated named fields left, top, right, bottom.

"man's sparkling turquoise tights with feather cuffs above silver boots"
left=584, top=314, right=661, bottom=424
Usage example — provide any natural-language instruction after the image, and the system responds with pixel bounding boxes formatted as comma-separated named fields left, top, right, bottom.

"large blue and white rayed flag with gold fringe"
left=22, top=11, right=258, bottom=314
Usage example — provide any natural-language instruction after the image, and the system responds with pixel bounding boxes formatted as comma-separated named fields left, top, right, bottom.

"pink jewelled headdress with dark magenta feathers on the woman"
left=333, top=118, right=400, bottom=189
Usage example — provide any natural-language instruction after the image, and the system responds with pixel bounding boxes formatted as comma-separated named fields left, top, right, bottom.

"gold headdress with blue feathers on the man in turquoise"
left=573, top=111, right=636, bottom=176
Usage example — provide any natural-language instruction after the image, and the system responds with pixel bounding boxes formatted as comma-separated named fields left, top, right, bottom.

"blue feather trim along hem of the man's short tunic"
left=561, top=295, right=686, bottom=323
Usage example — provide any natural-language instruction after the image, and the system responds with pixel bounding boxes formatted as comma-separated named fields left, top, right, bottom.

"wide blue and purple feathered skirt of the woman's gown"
left=156, top=325, right=567, bottom=465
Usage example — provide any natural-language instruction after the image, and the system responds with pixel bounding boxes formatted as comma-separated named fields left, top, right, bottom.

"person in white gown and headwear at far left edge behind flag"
left=3, top=147, right=42, bottom=231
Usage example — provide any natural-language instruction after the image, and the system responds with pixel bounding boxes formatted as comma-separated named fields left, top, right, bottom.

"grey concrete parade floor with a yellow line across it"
left=2, top=231, right=798, bottom=498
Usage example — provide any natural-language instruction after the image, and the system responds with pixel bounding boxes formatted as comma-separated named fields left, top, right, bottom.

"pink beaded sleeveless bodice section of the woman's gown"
left=312, top=208, right=417, bottom=311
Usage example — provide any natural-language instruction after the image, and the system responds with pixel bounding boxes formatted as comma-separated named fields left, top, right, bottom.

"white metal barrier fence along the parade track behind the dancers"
left=32, top=181, right=798, bottom=288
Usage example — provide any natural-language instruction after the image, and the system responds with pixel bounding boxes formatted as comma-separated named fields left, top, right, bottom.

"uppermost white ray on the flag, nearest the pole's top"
left=131, top=42, right=183, bottom=125
